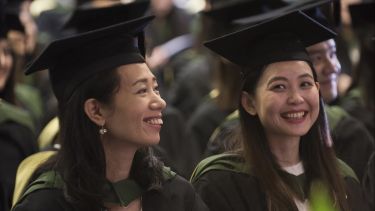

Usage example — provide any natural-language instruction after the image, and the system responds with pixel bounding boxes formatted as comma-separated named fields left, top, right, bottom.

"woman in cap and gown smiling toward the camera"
left=192, top=11, right=367, bottom=211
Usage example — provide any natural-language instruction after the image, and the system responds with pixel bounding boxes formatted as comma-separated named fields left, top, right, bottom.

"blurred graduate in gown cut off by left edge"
left=0, top=9, right=37, bottom=210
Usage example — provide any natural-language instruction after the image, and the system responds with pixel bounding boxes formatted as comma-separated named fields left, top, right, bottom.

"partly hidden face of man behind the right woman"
left=307, top=39, right=341, bottom=103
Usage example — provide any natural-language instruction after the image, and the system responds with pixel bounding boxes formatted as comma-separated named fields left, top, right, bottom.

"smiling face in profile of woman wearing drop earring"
left=105, top=63, right=166, bottom=146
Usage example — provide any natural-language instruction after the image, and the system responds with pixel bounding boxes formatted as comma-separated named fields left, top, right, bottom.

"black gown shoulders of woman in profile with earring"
left=12, top=176, right=208, bottom=211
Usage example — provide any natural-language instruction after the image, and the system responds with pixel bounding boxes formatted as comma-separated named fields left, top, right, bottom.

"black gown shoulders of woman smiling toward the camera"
left=193, top=153, right=369, bottom=211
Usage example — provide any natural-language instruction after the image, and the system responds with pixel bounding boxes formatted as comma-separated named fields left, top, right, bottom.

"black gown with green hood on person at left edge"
left=0, top=101, right=37, bottom=211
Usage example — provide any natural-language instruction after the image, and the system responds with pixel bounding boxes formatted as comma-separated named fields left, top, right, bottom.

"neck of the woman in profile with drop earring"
left=103, top=136, right=138, bottom=182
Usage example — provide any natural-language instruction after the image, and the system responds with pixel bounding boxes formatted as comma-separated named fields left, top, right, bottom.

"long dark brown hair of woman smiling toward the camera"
left=239, top=62, right=349, bottom=211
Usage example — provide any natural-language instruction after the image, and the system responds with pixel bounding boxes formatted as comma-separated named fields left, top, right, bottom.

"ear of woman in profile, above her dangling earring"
left=84, top=98, right=105, bottom=126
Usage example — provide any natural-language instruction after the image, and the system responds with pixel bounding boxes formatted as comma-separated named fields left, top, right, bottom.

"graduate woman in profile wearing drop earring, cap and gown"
left=13, top=17, right=206, bottom=211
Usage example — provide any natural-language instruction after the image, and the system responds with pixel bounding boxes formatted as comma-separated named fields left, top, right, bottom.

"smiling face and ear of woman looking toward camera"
left=242, top=61, right=319, bottom=139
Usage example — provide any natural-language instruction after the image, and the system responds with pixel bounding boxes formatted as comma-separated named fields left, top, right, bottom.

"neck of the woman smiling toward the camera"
left=268, top=134, right=301, bottom=167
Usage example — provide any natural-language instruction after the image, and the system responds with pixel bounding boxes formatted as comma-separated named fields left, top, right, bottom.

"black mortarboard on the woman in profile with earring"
left=25, top=16, right=154, bottom=102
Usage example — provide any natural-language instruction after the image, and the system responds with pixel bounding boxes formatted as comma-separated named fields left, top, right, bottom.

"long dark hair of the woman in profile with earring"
left=36, top=65, right=163, bottom=210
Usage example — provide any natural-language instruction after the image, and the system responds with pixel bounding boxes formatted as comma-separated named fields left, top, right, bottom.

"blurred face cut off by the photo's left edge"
left=0, top=39, right=13, bottom=90
